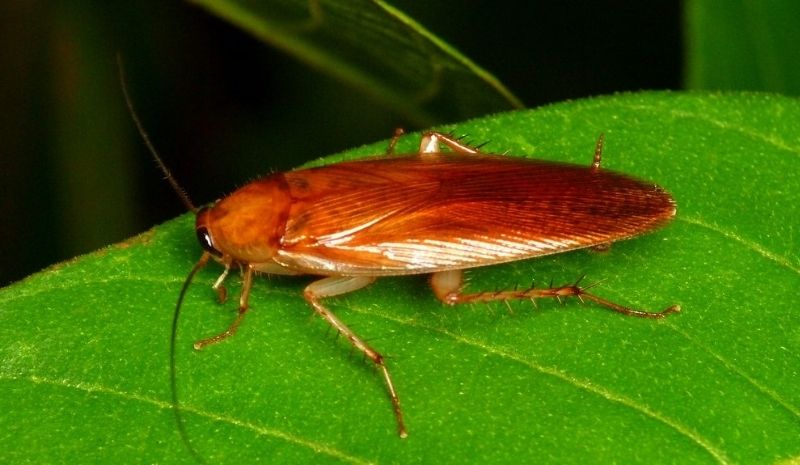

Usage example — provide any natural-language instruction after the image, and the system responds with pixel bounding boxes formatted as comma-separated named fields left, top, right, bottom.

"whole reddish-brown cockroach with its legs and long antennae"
left=123, top=62, right=680, bottom=450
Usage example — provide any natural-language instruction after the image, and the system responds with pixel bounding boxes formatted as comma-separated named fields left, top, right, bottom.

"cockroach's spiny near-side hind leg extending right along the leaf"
left=431, top=270, right=681, bottom=318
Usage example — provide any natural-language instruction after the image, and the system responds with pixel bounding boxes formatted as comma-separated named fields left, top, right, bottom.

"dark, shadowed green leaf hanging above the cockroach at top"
left=192, top=0, right=522, bottom=126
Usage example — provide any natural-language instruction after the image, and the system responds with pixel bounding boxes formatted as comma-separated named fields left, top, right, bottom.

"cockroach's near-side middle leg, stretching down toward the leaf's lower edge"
left=303, top=276, right=408, bottom=438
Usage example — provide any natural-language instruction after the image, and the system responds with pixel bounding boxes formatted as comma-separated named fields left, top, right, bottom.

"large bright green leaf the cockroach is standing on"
left=0, top=93, right=800, bottom=464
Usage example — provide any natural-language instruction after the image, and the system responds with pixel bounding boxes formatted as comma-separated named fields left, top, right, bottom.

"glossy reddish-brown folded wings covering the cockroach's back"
left=275, top=153, right=675, bottom=276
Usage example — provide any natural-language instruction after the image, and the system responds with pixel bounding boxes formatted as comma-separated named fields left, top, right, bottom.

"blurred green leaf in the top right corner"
left=685, top=0, right=800, bottom=95
